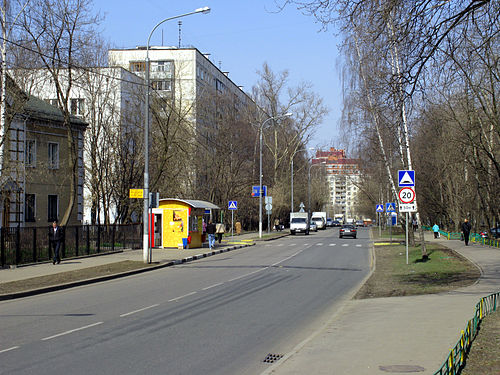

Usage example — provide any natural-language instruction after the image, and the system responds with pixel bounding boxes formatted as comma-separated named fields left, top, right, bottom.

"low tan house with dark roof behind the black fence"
left=0, top=76, right=86, bottom=227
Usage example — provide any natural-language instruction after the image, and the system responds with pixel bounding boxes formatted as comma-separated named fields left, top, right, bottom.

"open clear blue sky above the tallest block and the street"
left=94, top=0, right=342, bottom=147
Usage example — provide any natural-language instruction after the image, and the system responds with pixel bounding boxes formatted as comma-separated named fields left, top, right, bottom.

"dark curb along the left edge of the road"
left=0, top=243, right=255, bottom=301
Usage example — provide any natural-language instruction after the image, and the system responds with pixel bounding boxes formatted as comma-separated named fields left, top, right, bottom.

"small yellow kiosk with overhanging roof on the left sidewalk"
left=151, top=198, right=220, bottom=249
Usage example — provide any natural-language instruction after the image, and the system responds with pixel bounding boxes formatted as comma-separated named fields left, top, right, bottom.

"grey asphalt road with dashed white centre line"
left=0, top=228, right=370, bottom=375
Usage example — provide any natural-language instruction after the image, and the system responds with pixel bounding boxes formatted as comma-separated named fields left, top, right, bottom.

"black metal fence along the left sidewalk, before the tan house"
left=0, top=224, right=143, bottom=267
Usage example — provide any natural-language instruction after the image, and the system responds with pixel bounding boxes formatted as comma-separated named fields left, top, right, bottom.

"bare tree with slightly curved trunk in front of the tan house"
left=19, top=0, right=99, bottom=225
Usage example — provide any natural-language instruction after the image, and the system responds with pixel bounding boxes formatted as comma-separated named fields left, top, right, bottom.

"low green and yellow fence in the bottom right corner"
left=434, top=292, right=500, bottom=375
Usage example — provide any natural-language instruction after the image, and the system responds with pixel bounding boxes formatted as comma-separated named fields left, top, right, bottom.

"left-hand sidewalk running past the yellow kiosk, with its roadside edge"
left=0, top=232, right=285, bottom=301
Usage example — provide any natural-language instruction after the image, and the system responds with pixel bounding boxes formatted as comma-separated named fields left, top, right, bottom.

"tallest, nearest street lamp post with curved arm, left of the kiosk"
left=142, top=7, right=210, bottom=263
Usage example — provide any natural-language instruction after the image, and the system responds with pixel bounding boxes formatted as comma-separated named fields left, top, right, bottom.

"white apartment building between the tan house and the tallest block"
left=11, top=67, right=144, bottom=223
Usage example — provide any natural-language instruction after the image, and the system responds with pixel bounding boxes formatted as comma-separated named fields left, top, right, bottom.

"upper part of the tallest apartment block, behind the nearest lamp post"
left=108, top=46, right=254, bottom=135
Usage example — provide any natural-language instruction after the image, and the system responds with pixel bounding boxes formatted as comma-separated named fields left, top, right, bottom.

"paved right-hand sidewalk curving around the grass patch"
left=263, top=233, right=500, bottom=375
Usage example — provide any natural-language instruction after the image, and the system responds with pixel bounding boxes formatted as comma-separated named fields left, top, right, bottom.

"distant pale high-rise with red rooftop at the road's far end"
left=312, top=147, right=360, bottom=220
